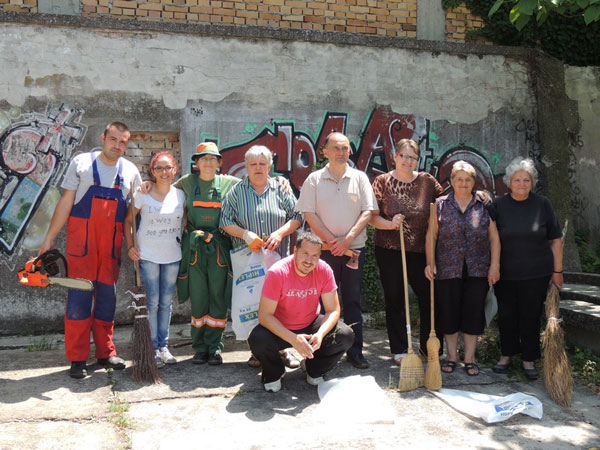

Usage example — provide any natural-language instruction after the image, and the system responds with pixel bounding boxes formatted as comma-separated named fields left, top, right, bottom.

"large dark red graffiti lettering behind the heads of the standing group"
left=200, top=107, right=506, bottom=195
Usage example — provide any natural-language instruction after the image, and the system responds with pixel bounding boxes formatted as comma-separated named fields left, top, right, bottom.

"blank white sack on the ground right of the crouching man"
left=316, top=375, right=396, bottom=424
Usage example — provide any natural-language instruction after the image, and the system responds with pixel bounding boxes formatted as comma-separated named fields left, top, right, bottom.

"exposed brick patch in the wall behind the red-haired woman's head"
left=125, top=131, right=182, bottom=180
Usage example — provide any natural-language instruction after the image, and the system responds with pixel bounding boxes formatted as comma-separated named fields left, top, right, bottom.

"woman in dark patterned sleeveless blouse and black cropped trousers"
left=425, top=161, right=500, bottom=376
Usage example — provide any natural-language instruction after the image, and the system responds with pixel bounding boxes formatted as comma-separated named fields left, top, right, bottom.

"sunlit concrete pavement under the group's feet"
left=0, top=325, right=600, bottom=450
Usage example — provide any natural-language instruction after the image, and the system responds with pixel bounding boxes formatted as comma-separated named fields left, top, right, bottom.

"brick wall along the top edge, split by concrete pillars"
left=0, top=0, right=489, bottom=44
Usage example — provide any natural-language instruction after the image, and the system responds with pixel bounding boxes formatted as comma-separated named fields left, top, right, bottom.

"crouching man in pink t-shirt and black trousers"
left=248, top=233, right=354, bottom=392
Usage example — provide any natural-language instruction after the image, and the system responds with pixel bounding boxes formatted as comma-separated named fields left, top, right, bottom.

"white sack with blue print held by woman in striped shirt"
left=231, top=247, right=281, bottom=341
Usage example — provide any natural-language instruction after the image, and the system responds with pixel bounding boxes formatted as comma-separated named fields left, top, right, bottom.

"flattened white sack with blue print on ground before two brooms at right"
left=430, top=389, right=544, bottom=423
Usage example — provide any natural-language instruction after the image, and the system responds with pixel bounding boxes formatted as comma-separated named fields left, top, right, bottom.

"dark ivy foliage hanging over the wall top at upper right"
left=442, top=0, right=600, bottom=66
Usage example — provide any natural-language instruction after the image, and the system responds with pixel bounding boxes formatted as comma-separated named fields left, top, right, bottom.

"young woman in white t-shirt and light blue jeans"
left=124, top=152, right=185, bottom=367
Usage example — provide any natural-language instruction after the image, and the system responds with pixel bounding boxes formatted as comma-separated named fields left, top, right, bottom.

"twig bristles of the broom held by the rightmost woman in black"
left=542, top=284, right=573, bottom=407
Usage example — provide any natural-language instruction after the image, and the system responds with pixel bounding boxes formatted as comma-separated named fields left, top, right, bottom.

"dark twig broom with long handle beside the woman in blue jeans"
left=128, top=183, right=161, bottom=384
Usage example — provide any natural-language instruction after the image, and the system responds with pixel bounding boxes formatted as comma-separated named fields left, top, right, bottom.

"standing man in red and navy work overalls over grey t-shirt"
left=39, top=122, right=141, bottom=378
